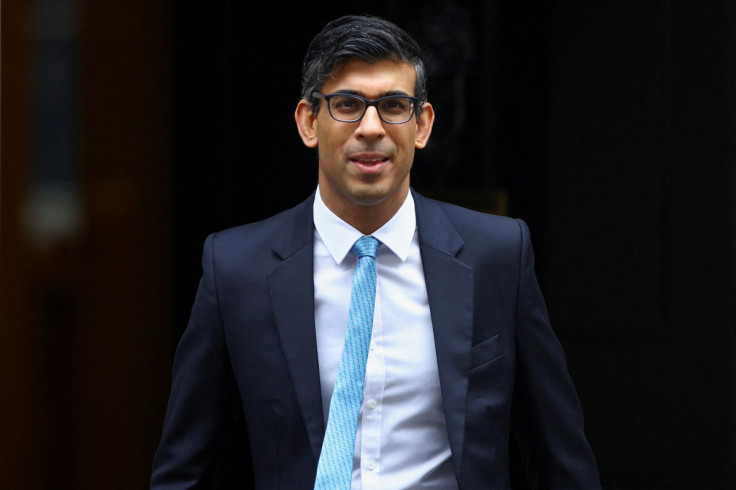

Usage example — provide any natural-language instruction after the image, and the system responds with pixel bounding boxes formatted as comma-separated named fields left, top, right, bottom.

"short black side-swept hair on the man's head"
left=302, top=15, right=427, bottom=117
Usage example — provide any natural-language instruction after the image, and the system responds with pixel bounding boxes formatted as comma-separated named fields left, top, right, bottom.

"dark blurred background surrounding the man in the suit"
left=0, top=0, right=736, bottom=490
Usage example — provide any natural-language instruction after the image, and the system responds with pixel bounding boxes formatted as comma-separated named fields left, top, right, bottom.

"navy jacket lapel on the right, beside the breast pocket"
left=413, top=193, right=473, bottom=474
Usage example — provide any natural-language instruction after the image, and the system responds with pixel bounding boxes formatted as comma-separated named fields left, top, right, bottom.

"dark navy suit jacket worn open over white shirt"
left=152, top=193, right=600, bottom=490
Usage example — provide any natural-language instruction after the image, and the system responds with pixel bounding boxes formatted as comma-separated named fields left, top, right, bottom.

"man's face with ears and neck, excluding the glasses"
left=297, top=60, right=434, bottom=224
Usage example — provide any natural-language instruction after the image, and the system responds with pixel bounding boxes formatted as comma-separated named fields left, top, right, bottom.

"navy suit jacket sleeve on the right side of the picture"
left=511, top=221, right=600, bottom=490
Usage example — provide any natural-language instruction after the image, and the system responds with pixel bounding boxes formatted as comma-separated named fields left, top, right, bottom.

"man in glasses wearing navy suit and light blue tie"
left=152, top=13, right=599, bottom=490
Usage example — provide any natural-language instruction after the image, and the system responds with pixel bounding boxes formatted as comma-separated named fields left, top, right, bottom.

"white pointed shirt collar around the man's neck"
left=314, top=186, right=417, bottom=264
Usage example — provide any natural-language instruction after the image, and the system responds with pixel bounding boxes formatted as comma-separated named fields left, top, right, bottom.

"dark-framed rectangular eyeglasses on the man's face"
left=312, top=92, right=419, bottom=124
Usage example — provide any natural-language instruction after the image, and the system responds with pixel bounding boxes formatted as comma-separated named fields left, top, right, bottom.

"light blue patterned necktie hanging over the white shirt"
left=314, top=236, right=380, bottom=490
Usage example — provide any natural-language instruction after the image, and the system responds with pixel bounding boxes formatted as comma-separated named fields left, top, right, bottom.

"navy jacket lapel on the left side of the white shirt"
left=268, top=196, right=324, bottom=457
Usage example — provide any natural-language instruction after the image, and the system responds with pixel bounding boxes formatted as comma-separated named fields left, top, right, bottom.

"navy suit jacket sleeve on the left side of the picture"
left=151, top=235, right=247, bottom=489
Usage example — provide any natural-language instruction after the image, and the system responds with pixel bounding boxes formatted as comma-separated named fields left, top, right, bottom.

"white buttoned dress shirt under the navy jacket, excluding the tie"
left=314, top=189, right=457, bottom=490
